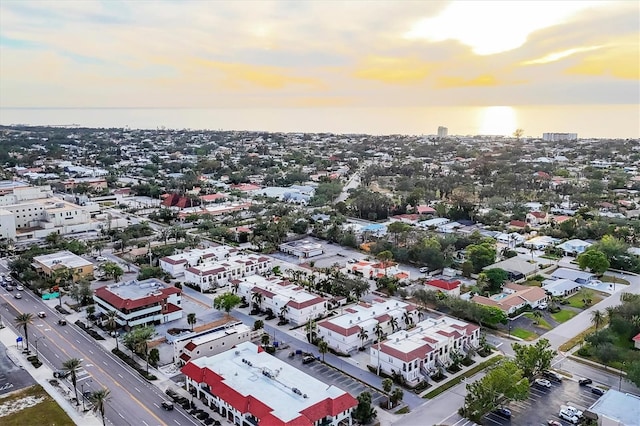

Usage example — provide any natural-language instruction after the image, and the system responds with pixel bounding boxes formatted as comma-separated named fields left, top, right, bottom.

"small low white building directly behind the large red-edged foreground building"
left=173, top=322, right=262, bottom=366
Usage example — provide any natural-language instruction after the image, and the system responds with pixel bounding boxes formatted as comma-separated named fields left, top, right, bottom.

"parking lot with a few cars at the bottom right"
left=483, top=379, right=599, bottom=426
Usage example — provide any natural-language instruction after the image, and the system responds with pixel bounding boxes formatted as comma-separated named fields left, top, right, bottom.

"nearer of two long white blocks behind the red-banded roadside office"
left=184, top=255, right=271, bottom=291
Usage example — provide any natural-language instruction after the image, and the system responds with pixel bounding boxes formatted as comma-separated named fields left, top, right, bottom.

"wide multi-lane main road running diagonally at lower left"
left=0, top=262, right=200, bottom=426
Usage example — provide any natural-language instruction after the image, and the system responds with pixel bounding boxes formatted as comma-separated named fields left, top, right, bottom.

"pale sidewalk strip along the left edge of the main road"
left=0, top=327, right=102, bottom=426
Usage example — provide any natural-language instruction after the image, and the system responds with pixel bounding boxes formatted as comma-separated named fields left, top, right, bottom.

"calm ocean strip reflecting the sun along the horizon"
left=0, top=105, right=640, bottom=139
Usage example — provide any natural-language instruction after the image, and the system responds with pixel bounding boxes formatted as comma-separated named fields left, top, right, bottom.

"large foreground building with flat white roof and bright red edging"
left=182, top=342, right=358, bottom=426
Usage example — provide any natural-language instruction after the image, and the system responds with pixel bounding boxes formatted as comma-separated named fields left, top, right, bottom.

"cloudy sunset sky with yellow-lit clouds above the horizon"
left=0, top=0, right=640, bottom=113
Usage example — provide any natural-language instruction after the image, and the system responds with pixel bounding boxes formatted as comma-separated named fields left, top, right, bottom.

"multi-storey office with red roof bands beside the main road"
left=93, top=279, right=182, bottom=329
